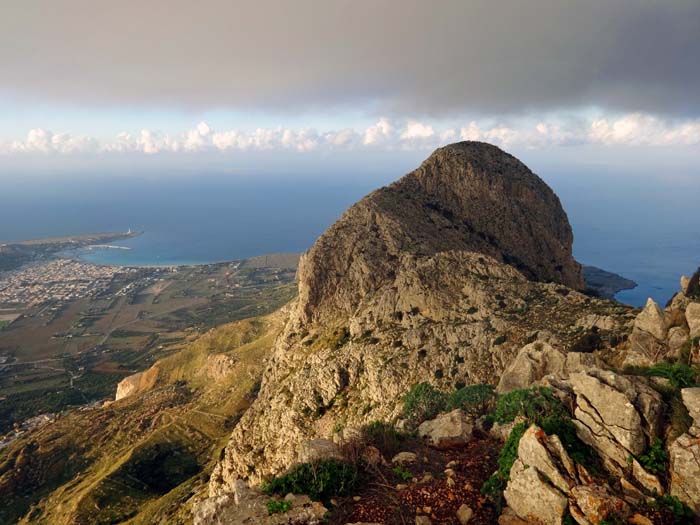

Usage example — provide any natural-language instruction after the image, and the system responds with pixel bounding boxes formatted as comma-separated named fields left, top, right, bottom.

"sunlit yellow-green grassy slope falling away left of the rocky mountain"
left=0, top=313, right=282, bottom=525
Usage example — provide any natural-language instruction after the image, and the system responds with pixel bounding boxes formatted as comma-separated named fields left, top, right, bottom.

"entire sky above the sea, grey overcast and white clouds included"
left=0, top=0, right=700, bottom=178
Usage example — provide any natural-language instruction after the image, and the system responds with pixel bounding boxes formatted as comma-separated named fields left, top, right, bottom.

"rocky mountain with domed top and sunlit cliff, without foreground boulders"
left=210, top=142, right=612, bottom=495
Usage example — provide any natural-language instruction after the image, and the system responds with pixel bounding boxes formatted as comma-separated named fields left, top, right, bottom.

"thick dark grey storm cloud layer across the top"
left=0, top=0, right=700, bottom=116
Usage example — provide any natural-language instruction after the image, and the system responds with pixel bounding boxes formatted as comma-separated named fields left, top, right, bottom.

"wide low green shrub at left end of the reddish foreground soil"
left=262, top=459, right=359, bottom=504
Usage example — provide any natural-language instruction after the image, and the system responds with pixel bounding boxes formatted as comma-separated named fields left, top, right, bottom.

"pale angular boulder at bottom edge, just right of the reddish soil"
left=503, top=459, right=569, bottom=525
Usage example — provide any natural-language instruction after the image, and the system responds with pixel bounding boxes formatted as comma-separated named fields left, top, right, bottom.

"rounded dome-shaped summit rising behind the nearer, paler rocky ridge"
left=299, top=142, right=583, bottom=322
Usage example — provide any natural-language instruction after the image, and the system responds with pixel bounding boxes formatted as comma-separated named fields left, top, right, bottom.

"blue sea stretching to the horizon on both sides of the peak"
left=0, top=172, right=700, bottom=306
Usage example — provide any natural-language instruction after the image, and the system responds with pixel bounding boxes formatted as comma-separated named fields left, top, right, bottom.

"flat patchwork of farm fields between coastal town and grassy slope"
left=0, top=255, right=298, bottom=434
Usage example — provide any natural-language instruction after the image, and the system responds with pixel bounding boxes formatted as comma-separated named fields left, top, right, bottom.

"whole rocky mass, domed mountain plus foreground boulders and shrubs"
left=195, top=142, right=700, bottom=525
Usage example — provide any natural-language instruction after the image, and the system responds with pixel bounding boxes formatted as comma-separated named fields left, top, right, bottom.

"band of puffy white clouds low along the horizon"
left=0, top=113, right=700, bottom=155
